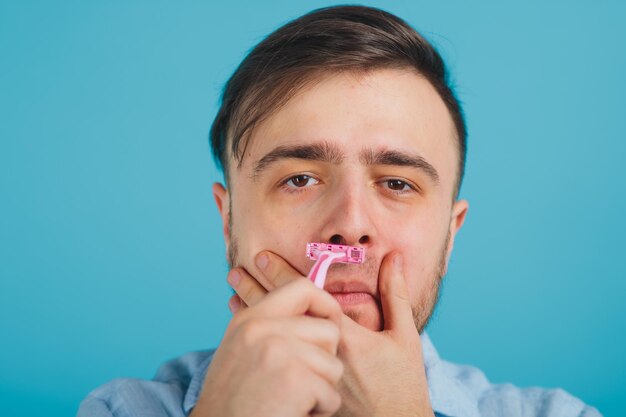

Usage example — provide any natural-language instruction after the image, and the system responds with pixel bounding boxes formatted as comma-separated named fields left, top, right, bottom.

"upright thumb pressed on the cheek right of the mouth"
left=378, top=253, right=416, bottom=337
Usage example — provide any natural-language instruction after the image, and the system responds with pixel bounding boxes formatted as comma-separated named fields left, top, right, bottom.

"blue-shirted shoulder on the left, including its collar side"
left=78, top=351, right=213, bottom=417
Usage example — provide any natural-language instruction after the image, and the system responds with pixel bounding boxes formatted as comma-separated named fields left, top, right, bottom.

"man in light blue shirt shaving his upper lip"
left=79, top=6, right=599, bottom=417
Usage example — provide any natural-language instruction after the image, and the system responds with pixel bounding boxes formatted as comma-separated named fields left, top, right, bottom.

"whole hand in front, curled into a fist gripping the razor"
left=191, top=269, right=343, bottom=417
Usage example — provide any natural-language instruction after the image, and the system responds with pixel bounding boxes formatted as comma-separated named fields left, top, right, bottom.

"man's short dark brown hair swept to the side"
left=210, top=6, right=467, bottom=198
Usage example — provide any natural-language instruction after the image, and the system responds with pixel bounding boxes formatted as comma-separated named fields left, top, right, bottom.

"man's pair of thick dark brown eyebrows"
left=252, top=141, right=439, bottom=185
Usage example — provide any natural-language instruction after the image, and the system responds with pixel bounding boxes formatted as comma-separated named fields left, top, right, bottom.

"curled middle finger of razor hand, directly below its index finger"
left=282, top=316, right=341, bottom=355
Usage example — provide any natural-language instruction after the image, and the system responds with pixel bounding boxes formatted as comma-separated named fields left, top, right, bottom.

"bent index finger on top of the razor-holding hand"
left=254, top=279, right=342, bottom=328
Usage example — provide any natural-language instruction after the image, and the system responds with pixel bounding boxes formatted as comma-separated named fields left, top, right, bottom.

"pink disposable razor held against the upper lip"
left=306, top=243, right=365, bottom=289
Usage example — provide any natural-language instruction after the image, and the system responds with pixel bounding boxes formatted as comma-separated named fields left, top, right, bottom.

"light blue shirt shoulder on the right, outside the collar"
left=440, top=360, right=601, bottom=417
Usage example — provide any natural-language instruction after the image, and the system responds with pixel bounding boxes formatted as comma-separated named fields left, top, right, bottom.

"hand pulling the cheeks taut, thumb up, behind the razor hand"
left=231, top=252, right=433, bottom=416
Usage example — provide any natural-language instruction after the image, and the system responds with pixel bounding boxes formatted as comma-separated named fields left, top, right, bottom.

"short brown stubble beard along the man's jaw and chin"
left=228, top=210, right=450, bottom=334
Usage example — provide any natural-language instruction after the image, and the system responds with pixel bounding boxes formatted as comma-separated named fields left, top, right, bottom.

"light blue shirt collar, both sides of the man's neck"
left=183, top=332, right=480, bottom=417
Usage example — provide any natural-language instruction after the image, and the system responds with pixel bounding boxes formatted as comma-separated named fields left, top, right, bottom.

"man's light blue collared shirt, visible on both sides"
left=78, top=333, right=600, bottom=417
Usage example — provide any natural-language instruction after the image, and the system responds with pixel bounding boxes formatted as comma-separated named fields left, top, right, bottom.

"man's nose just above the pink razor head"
left=321, top=183, right=376, bottom=247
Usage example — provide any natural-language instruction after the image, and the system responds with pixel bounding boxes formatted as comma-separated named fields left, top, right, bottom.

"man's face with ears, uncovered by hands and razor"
left=214, top=69, right=467, bottom=331
